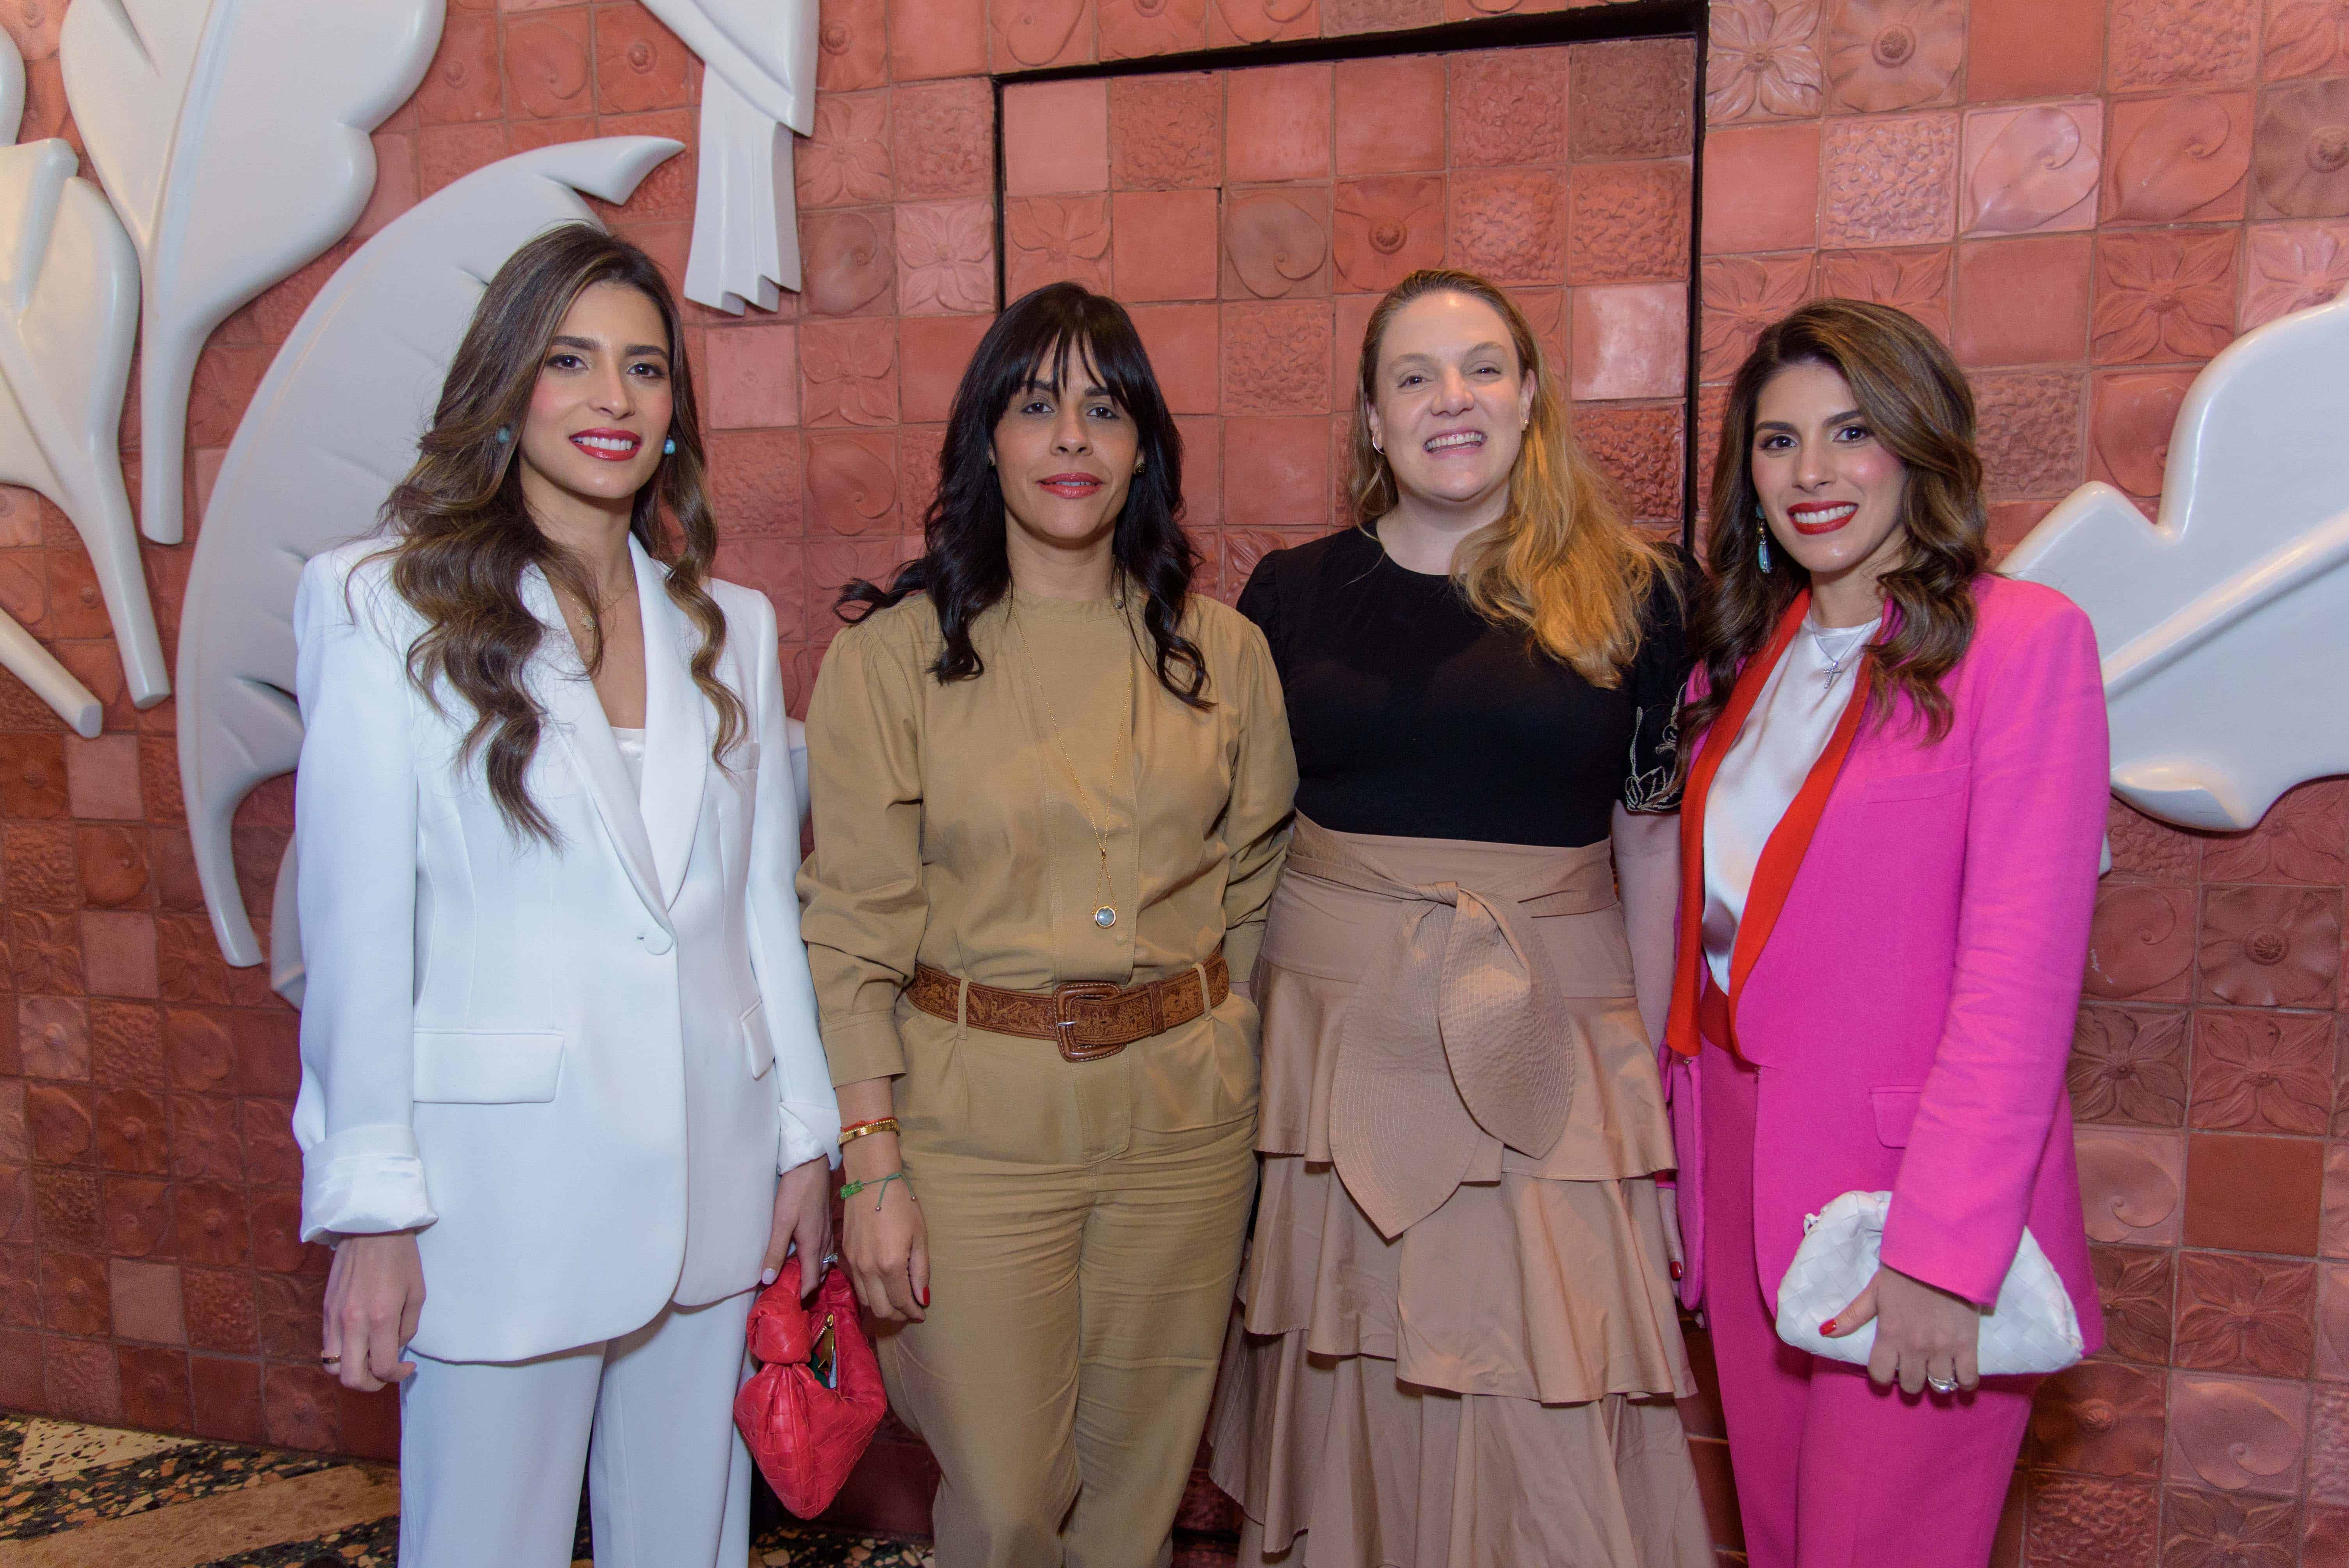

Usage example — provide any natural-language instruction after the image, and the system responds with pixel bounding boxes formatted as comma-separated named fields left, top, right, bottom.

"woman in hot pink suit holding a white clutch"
left=1661, top=301, right=2107, bottom=1568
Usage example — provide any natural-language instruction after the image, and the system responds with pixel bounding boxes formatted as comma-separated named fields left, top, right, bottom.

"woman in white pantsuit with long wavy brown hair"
left=294, top=225, right=839, bottom=1568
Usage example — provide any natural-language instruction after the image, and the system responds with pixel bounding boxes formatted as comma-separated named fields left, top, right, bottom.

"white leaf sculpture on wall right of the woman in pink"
left=2004, top=296, right=2349, bottom=829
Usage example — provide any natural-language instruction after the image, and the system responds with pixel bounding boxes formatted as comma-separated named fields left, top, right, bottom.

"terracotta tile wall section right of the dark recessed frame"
left=1698, top=0, right=2349, bottom=1568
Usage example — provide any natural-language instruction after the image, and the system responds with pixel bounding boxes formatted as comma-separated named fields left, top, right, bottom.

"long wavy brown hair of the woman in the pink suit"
left=1684, top=301, right=1990, bottom=737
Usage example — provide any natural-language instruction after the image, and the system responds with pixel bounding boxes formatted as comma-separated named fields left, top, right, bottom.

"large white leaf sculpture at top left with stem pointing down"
left=59, top=0, right=444, bottom=545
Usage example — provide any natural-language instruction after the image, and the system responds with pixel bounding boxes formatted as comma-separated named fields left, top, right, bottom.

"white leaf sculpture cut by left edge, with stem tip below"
left=0, top=141, right=171, bottom=735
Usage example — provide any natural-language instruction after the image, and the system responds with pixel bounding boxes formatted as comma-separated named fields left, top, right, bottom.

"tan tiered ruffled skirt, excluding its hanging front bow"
left=1207, top=821, right=1713, bottom=1568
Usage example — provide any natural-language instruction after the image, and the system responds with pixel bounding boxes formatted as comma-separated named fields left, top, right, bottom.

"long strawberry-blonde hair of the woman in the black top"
left=1351, top=267, right=1668, bottom=688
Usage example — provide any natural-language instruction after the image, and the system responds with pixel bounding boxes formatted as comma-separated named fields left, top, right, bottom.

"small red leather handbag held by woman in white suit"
left=735, top=1267, right=888, bottom=1519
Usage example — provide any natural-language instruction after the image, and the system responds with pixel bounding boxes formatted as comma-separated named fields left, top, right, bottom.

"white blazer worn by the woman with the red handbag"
left=294, top=540, right=841, bottom=1361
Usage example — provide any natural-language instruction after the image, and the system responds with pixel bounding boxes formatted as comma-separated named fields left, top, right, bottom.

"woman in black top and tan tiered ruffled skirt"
left=1212, top=272, right=1713, bottom=1568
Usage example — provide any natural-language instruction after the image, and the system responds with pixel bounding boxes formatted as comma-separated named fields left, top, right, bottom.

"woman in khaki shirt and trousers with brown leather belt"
left=798, top=284, right=1297, bottom=1568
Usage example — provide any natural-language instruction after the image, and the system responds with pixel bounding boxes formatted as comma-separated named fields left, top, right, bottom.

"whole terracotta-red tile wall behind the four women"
left=0, top=0, right=2349, bottom=1566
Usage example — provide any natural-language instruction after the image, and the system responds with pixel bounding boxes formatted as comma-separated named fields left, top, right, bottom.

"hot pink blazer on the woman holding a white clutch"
left=1658, top=577, right=2109, bottom=1350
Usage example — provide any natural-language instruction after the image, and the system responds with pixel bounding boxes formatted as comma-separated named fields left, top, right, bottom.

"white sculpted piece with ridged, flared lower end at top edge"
left=643, top=0, right=815, bottom=315
